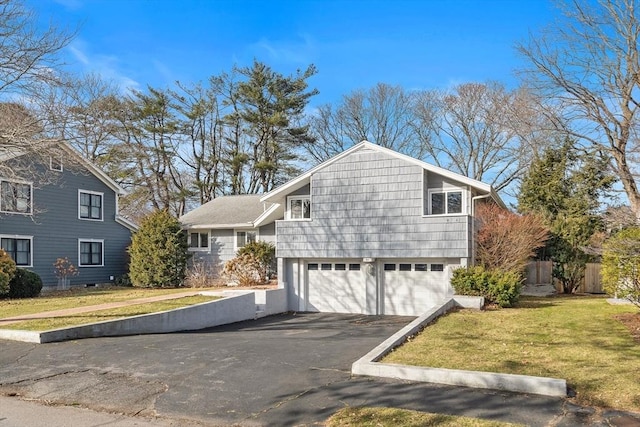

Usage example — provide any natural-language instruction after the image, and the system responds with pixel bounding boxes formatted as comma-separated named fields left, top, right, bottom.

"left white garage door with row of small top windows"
left=306, top=260, right=366, bottom=313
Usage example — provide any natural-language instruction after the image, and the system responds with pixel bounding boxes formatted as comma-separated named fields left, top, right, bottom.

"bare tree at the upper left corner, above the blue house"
left=0, top=0, right=73, bottom=185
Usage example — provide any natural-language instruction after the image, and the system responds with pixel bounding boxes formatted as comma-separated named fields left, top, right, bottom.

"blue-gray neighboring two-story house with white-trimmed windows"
left=0, top=144, right=135, bottom=287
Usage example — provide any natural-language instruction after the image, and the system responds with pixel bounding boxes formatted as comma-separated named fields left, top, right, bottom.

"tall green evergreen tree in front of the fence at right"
left=518, top=140, right=615, bottom=293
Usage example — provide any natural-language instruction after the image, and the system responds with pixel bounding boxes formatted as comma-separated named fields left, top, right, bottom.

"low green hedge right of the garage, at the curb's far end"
left=451, top=266, right=522, bottom=307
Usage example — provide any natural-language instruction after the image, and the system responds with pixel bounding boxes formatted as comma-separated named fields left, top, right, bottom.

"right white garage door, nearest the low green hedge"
left=381, top=260, right=449, bottom=316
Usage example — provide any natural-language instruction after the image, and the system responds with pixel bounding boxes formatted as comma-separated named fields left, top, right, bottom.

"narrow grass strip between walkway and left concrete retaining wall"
left=0, top=295, right=218, bottom=331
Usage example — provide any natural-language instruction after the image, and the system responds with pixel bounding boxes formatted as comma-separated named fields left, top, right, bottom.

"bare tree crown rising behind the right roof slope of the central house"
left=413, top=83, right=546, bottom=196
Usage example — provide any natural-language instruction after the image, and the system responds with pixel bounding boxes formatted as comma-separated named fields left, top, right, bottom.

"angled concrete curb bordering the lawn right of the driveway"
left=351, top=295, right=567, bottom=397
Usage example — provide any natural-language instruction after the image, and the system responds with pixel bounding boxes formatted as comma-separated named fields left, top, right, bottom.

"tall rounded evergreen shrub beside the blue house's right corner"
left=129, top=210, right=189, bottom=288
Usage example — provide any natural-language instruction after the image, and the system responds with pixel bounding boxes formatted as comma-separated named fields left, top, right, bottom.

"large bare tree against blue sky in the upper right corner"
left=518, top=0, right=640, bottom=218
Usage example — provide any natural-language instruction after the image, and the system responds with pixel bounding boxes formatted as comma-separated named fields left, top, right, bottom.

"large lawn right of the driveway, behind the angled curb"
left=382, top=296, right=640, bottom=411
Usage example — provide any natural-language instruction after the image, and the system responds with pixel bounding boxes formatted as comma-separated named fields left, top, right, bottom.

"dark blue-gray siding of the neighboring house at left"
left=0, top=166, right=131, bottom=286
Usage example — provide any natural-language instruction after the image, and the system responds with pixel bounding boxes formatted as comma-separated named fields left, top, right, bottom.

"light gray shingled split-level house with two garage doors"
left=182, top=141, right=504, bottom=315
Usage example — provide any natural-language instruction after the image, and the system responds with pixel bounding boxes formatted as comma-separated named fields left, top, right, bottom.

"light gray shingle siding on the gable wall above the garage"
left=276, top=150, right=470, bottom=258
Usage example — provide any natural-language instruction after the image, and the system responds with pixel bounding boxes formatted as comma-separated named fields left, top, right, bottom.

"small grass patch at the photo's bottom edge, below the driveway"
left=325, top=408, right=520, bottom=427
